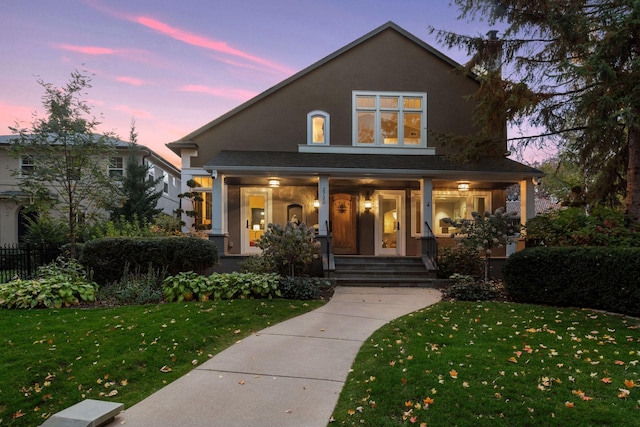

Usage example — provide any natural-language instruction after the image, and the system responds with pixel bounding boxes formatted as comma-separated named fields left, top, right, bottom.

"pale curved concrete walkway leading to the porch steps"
left=108, top=287, right=440, bottom=427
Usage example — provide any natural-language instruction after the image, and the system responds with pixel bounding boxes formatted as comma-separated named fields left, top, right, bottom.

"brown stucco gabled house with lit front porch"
left=167, top=22, right=541, bottom=278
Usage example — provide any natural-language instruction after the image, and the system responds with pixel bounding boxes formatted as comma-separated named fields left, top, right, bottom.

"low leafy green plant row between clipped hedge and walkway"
left=163, top=271, right=280, bottom=302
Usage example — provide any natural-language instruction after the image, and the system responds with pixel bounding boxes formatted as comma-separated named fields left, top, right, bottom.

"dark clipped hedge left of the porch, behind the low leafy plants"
left=79, top=237, right=219, bottom=285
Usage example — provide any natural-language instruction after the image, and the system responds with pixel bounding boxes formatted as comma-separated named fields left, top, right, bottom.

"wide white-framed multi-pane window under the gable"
left=353, top=91, right=427, bottom=147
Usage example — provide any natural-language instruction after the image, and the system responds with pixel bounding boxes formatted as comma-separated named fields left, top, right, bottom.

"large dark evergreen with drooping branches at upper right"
left=432, top=0, right=640, bottom=220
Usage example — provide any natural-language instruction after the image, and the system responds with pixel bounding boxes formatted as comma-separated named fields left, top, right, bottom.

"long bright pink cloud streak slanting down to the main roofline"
left=135, top=16, right=294, bottom=74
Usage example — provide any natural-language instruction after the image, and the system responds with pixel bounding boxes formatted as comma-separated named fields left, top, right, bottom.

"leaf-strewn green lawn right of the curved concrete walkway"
left=331, top=302, right=640, bottom=426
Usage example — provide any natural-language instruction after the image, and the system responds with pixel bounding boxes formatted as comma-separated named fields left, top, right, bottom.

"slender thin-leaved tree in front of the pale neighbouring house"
left=9, top=71, right=118, bottom=257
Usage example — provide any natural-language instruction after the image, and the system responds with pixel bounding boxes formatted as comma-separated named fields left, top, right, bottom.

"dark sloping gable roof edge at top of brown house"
left=166, top=21, right=462, bottom=155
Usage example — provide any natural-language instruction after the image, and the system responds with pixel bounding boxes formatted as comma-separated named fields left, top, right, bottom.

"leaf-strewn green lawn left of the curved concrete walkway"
left=0, top=299, right=323, bottom=426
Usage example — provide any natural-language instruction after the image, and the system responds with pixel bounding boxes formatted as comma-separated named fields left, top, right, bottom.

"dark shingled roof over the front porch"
left=205, top=150, right=544, bottom=182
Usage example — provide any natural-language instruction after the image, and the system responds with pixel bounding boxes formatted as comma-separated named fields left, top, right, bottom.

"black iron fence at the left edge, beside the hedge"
left=0, top=243, right=62, bottom=283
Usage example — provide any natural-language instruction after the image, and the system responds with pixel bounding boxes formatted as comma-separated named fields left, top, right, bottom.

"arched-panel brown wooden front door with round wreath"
left=331, top=194, right=357, bottom=255
